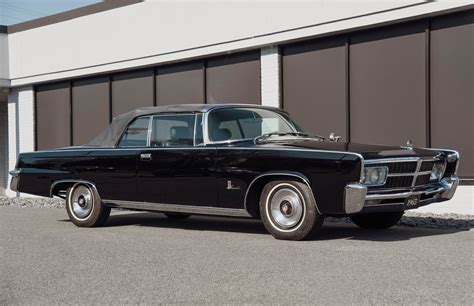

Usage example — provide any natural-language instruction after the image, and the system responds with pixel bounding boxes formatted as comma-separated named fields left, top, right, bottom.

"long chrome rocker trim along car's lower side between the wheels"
left=103, top=200, right=251, bottom=218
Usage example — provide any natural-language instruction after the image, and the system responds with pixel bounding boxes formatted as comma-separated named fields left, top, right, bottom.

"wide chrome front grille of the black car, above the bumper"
left=365, top=158, right=439, bottom=189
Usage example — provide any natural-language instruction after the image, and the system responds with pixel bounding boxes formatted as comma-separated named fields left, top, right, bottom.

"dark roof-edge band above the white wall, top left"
left=8, top=0, right=143, bottom=34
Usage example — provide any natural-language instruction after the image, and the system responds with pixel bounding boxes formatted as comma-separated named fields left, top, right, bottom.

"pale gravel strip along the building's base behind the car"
left=0, top=198, right=474, bottom=230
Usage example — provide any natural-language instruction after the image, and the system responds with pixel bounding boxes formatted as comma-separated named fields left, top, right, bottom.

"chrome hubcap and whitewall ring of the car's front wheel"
left=269, top=187, right=304, bottom=229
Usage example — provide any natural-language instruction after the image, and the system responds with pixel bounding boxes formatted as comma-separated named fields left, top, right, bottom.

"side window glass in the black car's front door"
left=150, top=114, right=196, bottom=148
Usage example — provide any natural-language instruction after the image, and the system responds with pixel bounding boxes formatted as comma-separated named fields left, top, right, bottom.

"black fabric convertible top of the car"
left=88, top=104, right=282, bottom=147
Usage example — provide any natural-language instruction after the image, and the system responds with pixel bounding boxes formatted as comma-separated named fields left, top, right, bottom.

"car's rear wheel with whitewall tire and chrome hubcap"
left=66, top=183, right=110, bottom=227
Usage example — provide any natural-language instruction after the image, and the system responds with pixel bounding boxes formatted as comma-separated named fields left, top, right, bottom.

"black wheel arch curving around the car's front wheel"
left=245, top=174, right=307, bottom=218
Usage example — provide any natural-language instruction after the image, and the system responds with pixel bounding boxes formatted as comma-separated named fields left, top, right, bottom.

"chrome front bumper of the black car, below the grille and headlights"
left=344, top=176, right=459, bottom=214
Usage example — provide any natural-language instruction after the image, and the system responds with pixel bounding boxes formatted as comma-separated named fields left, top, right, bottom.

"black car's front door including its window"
left=137, top=113, right=217, bottom=206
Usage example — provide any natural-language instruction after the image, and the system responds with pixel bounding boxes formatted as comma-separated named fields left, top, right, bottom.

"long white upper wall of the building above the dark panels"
left=9, top=0, right=471, bottom=86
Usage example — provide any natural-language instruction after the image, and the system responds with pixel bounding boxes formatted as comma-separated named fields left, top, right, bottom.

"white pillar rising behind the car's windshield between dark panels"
left=260, top=46, right=280, bottom=107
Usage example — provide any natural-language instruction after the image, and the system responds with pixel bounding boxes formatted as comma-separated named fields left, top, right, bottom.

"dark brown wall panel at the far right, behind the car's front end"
left=430, top=11, right=474, bottom=177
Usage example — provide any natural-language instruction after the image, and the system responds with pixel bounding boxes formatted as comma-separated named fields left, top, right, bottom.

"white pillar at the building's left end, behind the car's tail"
left=5, top=87, right=35, bottom=196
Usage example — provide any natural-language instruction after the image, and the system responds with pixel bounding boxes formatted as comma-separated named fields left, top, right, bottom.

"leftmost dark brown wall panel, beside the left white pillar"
left=36, top=82, right=71, bottom=150
